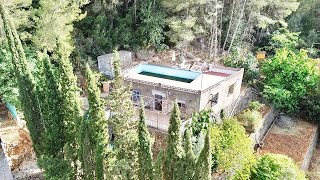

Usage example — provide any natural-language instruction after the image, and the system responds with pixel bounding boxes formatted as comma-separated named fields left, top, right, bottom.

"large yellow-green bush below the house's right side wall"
left=210, top=119, right=255, bottom=179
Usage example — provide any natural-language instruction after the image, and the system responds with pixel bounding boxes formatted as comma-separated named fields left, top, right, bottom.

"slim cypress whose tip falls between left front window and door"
left=138, top=98, right=154, bottom=180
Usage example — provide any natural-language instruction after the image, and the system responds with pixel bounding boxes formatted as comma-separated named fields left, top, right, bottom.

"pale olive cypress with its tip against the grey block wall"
left=106, top=52, right=138, bottom=179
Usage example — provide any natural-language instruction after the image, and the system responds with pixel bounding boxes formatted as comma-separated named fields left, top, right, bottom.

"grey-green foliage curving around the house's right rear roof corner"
left=223, top=47, right=259, bottom=82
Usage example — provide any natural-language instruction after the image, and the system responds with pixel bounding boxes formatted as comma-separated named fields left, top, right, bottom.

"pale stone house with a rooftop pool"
left=123, top=64, right=244, bottom=131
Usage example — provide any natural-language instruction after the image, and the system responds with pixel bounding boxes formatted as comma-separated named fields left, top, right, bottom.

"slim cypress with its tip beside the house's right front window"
left=163, top=102, right=182, bottom=180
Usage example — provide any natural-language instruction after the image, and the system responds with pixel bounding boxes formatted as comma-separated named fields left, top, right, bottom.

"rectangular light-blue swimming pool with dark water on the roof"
left=131, top=64, right=201, bottom=83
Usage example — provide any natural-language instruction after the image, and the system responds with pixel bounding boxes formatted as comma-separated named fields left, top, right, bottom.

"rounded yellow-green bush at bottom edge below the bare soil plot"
left=251, top=154, right=306, bottom=180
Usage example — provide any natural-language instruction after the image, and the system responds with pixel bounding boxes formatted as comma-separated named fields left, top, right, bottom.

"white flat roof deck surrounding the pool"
left=124, top=64, right=239, bottom=93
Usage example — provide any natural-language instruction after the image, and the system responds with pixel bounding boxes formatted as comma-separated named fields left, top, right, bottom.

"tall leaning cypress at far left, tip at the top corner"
left=0, top=1, right=44, bottom=156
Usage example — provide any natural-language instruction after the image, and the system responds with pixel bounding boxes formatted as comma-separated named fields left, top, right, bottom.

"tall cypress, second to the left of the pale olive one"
left=58, top=43, right=83, bottom=179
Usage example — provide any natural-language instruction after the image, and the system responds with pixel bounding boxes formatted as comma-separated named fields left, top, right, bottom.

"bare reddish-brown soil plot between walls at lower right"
left=258, top=119, right=316, bottom=166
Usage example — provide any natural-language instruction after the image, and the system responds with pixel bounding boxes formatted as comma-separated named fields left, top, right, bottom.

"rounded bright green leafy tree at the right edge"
left=262, top=49, right=319, bottom=112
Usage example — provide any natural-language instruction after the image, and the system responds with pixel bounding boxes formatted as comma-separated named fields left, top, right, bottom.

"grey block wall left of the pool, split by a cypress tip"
left=98, top=51, right=132, bottom=78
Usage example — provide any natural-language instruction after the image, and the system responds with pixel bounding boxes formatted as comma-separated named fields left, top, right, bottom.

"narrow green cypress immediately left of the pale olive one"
left=83, top=65, right=109, bottom=179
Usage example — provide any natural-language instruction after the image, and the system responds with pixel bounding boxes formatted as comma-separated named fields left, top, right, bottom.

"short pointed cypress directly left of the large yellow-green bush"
left=193, top=129, right=212, bottom=180
